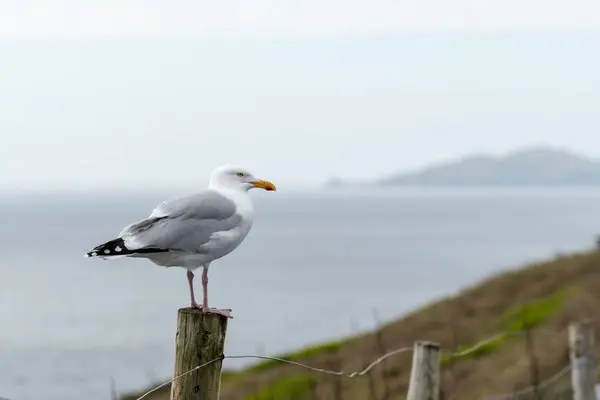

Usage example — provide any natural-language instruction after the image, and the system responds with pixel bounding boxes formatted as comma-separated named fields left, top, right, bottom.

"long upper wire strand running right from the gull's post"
left=136, top=329, right=570, bottom=400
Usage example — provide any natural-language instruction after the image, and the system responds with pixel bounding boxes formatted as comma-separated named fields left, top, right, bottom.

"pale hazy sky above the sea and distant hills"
left=0, top=0, right=600, bottom=189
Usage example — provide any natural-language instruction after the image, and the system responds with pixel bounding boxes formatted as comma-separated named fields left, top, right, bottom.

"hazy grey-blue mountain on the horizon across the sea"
left=338, top=148, right=600, bottom=186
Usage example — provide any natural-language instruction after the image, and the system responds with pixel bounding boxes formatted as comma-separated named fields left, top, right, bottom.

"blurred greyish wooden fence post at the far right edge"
left=569, top=322, right=596, bottom=400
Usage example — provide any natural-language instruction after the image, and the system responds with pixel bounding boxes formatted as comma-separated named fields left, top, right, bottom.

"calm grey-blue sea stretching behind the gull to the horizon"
left=0, top=188, right=600, bottom=400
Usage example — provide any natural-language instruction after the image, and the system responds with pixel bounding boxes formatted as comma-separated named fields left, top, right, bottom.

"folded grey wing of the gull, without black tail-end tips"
left=119, top=189, right=242, bottom=253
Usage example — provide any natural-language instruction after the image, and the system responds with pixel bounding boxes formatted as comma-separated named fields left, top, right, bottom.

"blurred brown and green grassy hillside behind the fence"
left=124, top=252, right=600, bottom=400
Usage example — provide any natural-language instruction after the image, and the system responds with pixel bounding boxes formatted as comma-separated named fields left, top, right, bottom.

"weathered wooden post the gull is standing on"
left=171, top=308, right=227, bottom=400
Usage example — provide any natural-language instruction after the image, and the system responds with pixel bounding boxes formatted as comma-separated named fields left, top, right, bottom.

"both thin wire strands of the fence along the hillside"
left=136, top=329, right=572, bottom=400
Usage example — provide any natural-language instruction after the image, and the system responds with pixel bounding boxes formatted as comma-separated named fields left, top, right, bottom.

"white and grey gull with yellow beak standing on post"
left=85, top=165, right=276, bottom=318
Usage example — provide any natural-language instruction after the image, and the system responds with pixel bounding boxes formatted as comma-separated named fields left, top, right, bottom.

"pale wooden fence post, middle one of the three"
left=407, top=341, right=440, bottom=400
